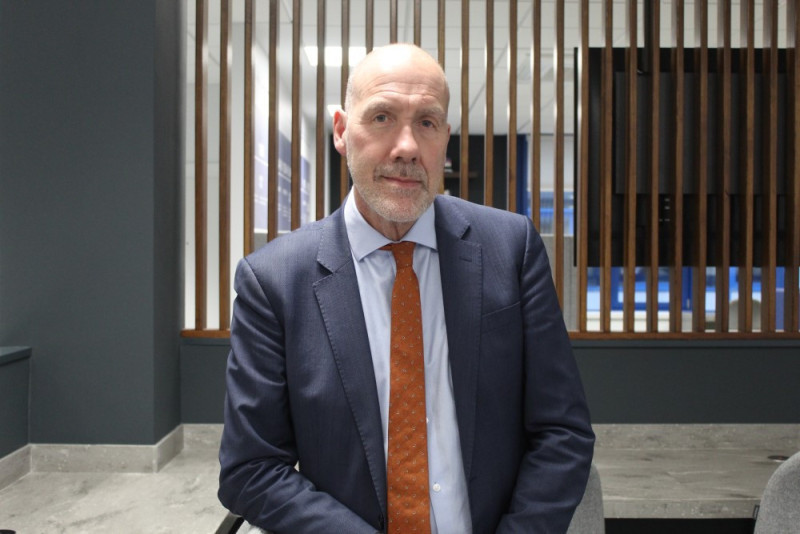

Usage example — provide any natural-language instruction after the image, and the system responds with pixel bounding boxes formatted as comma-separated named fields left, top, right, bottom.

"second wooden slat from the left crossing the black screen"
left=622, top=0, right=639, bottom=332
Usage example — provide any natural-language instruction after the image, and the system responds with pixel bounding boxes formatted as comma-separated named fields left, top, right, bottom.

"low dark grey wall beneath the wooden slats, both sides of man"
left=181, top=340, right=800, bottom=424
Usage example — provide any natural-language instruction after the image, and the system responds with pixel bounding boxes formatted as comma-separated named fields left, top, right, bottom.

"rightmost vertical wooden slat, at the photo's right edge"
left=783, top=0, right=800, bottom=332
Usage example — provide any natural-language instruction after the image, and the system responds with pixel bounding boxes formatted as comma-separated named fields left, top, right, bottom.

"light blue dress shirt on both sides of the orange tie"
left=344, top=194, right=472, bottom=534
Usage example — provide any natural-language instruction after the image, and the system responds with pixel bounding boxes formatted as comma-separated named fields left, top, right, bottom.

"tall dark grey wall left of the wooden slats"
left=0, top=0, right=183, bottom=444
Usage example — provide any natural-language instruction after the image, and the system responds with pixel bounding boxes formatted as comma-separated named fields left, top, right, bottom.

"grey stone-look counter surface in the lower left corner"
left=0, top=438, right=225, bottom=534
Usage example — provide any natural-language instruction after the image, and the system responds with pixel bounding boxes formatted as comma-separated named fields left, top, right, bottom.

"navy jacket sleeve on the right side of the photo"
left=497, top=220, right=594, bottom=533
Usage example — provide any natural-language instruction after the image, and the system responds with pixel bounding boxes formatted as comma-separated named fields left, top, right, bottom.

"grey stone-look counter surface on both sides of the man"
left=0, top=425, right=800, bottom=534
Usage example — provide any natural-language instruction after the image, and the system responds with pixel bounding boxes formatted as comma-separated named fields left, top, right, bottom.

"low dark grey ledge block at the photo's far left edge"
left=0, top=347, right=31, bottom=458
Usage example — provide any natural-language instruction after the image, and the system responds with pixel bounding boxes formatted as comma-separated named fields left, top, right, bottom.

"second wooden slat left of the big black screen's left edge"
left=553, top=0, right=564, bottom=306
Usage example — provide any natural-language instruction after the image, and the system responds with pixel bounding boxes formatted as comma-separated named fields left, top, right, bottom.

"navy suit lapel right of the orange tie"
left=435, top=197, right=483, bottom=482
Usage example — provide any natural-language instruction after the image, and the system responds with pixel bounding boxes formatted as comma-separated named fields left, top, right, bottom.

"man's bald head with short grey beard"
left=333, top=44, right=450, bottom=239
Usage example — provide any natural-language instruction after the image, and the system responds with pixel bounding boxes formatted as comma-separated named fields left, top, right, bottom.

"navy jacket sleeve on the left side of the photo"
left=218, top=259, right=376, bottom=533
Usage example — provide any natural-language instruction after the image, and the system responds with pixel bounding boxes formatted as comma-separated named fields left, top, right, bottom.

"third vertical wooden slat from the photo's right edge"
left=739, top=0, right=755, bottom=332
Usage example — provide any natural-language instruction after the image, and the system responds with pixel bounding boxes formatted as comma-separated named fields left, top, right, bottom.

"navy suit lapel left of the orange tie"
left=314, top=209, right=386, bottom=511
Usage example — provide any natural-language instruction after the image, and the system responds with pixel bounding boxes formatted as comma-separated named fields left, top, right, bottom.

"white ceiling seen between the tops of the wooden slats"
left=187, top=0, right=786, bottom=133
